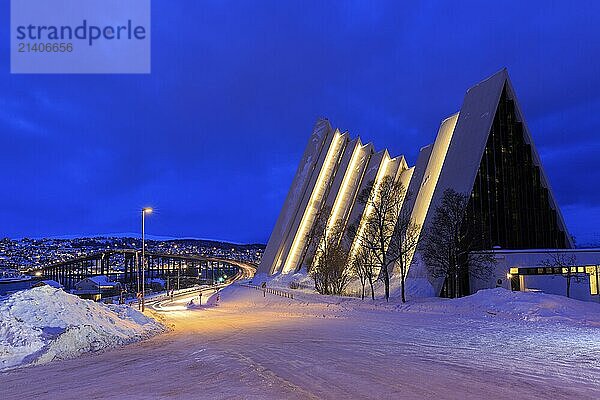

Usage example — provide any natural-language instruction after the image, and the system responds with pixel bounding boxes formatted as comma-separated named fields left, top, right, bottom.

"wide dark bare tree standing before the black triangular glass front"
left=422, top=189, right=495, bottom=297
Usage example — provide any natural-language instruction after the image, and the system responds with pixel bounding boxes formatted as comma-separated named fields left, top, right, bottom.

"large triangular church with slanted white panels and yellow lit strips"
left=258, top=69, right=600, bottom=296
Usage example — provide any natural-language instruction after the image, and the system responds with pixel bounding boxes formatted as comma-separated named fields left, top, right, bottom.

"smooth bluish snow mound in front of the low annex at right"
left=398, top=288, right=600, bottom=327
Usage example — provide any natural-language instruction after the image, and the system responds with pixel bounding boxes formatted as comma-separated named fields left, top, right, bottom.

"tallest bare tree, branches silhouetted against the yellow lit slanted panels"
left=356, top=176, right=406, bottom=300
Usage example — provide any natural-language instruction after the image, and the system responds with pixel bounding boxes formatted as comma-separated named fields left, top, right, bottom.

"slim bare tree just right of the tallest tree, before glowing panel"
left=388, top=206, right=421, bottom=303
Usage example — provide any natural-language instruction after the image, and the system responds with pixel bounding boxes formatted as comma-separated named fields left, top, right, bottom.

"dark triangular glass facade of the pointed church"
left=467, top=86, right=570, bottom=250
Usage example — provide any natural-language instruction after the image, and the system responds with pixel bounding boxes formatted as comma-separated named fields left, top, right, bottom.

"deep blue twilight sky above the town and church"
left=0, top=0, right=600, bottom=244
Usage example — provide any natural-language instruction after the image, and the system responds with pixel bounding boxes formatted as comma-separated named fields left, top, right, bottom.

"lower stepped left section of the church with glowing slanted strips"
left=259, top=120, right=412, bottom=275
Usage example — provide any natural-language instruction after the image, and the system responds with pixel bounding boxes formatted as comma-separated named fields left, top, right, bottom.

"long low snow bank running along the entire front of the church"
left=227, top=285, right=600, bottom=327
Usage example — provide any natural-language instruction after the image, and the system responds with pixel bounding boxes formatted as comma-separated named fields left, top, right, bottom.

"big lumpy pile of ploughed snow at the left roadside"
left=0, top=286, right=164, bottom=371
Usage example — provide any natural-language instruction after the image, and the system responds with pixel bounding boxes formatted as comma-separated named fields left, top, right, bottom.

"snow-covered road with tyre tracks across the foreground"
left=0, top=288, right=600, bottom=400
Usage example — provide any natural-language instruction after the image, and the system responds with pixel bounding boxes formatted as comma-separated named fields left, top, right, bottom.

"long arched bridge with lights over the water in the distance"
left=41, top=249, right=256, bottom=291
